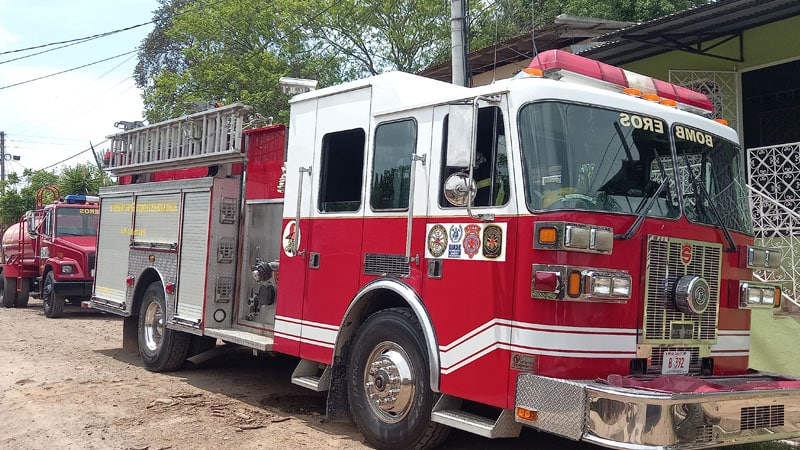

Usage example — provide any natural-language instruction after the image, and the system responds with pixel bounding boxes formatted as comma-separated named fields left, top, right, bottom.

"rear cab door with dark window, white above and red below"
left=290, top=87, right=372, bottom=361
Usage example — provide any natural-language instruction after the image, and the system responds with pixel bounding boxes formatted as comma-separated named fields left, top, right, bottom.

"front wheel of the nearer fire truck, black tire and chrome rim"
left=347, top=308, right=450, bottom=450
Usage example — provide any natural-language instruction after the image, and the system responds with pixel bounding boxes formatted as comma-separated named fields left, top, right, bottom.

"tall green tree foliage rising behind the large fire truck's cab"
left=135, top=0, right=708, bottom=122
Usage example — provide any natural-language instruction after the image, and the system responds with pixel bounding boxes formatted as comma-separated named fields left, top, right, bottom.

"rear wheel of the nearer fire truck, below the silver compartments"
left=138, top=281, right=191, bottom=372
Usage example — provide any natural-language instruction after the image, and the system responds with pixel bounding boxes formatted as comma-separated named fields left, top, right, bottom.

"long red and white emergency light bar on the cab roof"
left=528, top=50, right=714, bottom=113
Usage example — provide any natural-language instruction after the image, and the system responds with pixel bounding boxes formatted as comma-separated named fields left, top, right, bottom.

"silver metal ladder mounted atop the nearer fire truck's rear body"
left=104, top=103, right=253, bottom=176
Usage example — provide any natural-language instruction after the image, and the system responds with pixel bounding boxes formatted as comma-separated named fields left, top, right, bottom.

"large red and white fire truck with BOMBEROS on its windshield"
left=90, top=51, right=800, bottom=449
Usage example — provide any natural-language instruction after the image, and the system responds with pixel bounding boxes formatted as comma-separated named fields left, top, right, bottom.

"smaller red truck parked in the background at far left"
left=0, top=186, right=100, bottom=317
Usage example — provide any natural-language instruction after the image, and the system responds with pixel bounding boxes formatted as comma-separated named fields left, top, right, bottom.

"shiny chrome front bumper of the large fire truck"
left=516, top=374, right=800, bottom=449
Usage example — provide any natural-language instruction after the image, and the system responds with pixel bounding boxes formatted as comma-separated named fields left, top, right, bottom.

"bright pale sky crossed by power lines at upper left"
left=0, top=0, right=158, bottom=174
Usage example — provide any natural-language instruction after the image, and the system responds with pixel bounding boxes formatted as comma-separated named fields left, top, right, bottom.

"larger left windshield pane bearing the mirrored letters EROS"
left=520, top=102, right=680, bottom=218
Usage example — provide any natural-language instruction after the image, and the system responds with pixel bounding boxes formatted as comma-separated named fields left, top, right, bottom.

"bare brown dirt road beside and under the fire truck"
left=0, top=300, right=598, bottom=450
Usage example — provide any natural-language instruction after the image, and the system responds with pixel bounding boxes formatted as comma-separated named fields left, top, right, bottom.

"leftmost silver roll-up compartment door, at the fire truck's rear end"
left=94, top=192, right=133, bottom=312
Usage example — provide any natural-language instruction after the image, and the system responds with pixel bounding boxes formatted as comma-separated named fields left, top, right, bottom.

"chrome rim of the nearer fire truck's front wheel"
left=364, top=341, right=415, bottom=423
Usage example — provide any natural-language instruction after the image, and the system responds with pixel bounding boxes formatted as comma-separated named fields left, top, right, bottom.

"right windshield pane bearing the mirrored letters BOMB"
left=672, top=124, right=753, bottom=234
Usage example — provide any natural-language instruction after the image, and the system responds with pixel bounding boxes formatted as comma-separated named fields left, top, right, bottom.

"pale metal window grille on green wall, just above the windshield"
left=669, top=70, right=738, bottom=130
